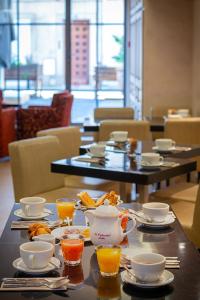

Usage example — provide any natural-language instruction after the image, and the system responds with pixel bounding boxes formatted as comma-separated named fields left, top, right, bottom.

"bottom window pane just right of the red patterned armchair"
left=71, top=90, right=96, bottom=123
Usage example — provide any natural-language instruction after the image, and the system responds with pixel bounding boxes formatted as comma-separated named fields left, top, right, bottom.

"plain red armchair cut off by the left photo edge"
left=0, top=90, right=16, bottom=157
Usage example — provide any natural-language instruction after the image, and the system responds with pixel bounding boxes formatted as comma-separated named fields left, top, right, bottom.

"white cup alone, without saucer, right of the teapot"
left=142, top=202, right=169, bottom=223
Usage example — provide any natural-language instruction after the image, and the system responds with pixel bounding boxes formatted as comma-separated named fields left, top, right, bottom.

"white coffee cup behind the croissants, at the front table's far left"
left=20, top=197, right=46, bottom=217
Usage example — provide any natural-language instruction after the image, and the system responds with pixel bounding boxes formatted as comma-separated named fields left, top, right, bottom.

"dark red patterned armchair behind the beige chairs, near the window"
left=17, top=92, right=73, bottom=139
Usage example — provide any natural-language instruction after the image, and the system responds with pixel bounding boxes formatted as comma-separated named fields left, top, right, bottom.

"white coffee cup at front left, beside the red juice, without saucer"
left=19, top=241, right=54, bottom=269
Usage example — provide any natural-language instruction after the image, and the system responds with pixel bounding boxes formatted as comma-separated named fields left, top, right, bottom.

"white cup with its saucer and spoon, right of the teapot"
left=128, top=202, right=176, bottom=229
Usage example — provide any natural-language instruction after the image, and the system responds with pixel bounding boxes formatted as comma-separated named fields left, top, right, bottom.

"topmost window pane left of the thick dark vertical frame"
left=19, top=0, right=65, bottom=23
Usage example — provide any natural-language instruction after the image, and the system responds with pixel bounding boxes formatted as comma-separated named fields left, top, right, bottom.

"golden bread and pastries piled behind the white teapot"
left=77, top=191, right=122, bottom=208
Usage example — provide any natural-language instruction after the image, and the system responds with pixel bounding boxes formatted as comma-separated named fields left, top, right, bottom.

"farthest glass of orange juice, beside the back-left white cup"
left=56, top=198, right=75, bottom=225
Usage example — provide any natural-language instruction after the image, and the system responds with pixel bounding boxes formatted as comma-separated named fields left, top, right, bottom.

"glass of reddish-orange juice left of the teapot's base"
left=61, top=234, right=84, bottom=266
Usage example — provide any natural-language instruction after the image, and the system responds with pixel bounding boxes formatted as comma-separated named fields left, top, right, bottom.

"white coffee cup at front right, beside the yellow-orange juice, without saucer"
left=131, top=253, right=166, bottom=282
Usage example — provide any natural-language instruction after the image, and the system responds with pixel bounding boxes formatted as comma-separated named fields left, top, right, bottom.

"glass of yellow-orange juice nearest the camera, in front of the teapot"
left=96, top=245, right=121, bottom=276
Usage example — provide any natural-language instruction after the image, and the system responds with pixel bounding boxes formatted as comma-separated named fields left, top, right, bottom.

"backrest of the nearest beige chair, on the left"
left=9, top=136, right=64, bottom=201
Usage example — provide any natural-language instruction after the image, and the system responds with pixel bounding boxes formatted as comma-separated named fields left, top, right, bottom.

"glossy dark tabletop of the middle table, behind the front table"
left=51, top=152, right=196, bottom=185
